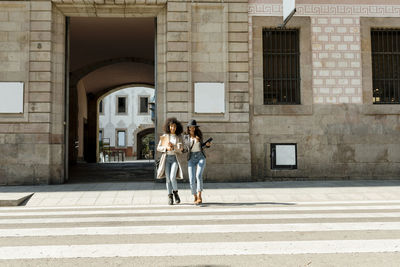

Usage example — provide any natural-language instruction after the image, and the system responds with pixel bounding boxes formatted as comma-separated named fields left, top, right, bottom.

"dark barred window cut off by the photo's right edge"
left=371, top=29, right=400, bottom=104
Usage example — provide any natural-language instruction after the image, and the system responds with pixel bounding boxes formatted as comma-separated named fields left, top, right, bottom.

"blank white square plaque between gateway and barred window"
left=194, top=83, right=225, bottom=113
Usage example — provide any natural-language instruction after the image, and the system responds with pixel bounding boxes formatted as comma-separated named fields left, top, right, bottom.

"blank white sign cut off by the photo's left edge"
left=0, top=82, right=24, bottom=113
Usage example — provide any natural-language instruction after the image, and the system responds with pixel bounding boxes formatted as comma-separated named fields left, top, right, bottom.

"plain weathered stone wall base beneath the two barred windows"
left=251, top=104, right=400, bottom=179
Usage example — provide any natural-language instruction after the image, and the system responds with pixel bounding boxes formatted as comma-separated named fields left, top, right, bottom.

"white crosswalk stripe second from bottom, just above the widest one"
left=0, top=222, right=400, bottom=237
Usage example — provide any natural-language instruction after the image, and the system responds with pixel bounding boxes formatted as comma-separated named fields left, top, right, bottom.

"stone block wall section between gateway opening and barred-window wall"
left=162, top=1, right=251, bottom=181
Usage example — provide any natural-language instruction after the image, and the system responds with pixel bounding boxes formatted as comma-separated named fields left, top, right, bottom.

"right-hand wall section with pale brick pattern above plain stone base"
left=249, top=0, right=400, bottom=179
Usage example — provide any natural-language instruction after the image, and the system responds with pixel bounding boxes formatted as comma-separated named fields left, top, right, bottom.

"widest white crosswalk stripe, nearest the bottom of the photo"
left=0, top=239, right=400, bottom=260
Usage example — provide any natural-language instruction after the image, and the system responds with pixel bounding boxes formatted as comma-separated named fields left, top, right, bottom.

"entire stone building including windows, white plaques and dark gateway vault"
left=0, top=0, right=400, bottom=184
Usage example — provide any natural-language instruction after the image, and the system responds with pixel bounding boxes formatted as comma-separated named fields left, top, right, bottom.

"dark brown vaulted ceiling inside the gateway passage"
left=69, top=17, right=155, bottom=94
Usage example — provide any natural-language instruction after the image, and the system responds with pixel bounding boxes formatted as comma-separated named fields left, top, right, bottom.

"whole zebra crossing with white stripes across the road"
left=0, top=201, right=400, bottom=260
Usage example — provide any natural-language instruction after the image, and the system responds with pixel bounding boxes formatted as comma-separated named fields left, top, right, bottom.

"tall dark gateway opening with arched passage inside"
left=68, top=17, right=156, bottom=182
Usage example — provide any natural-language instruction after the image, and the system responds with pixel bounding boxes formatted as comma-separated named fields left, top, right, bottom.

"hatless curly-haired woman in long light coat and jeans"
left=157, top=118, right=183, bottom=205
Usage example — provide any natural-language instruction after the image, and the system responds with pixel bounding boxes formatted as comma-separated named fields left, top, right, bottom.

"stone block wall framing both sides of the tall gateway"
left=0, top=0, right=251, bottom=184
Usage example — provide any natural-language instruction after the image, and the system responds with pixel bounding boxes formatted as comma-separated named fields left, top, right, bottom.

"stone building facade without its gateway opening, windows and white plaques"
left=0, top=0, right=400, bottom=184
